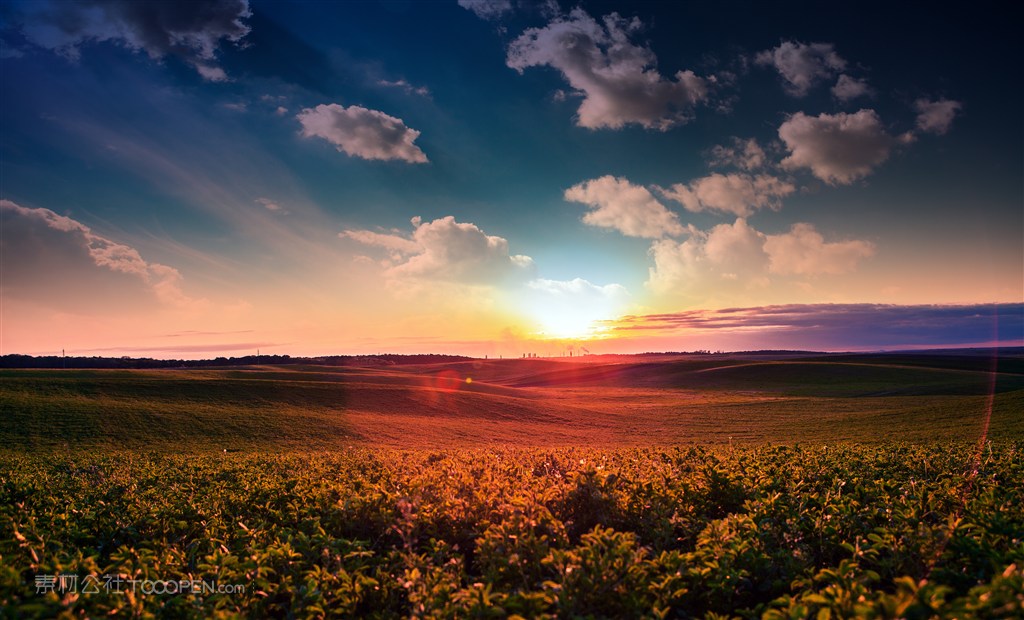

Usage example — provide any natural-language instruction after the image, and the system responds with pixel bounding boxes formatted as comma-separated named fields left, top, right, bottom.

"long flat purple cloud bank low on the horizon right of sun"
left=612, top=303, right=1024, bottom=350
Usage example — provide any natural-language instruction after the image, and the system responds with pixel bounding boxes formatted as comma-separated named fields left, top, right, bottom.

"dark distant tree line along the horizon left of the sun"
left=0, top=354, right=473, bottom=369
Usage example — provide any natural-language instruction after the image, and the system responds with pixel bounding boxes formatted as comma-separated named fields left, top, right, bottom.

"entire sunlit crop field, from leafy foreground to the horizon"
left=0, top=356, right=1024, bottom=618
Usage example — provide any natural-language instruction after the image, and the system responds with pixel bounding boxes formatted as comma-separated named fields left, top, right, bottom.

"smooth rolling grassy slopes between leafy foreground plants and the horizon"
left=0, top=356, right=1024, bottom=450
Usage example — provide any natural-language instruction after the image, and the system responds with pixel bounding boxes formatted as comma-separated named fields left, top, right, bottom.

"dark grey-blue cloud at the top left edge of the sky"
left=23, top=0, right=252, bottom=82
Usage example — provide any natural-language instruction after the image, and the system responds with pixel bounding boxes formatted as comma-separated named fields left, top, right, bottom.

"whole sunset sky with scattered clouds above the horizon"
left=0, top=0, right=1024, bottom=358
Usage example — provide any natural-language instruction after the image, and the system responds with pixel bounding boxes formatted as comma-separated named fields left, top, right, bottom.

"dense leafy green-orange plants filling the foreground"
left=0, top=443, right=1024, bottom=618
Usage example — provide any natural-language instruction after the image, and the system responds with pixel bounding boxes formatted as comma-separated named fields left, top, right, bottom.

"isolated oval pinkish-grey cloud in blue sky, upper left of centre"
left=295, top=104, right=427, bottom=164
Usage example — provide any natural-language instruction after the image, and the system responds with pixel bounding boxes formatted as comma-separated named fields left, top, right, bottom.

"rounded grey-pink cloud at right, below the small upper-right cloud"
left=778, top=110, right=898, bottom=184
